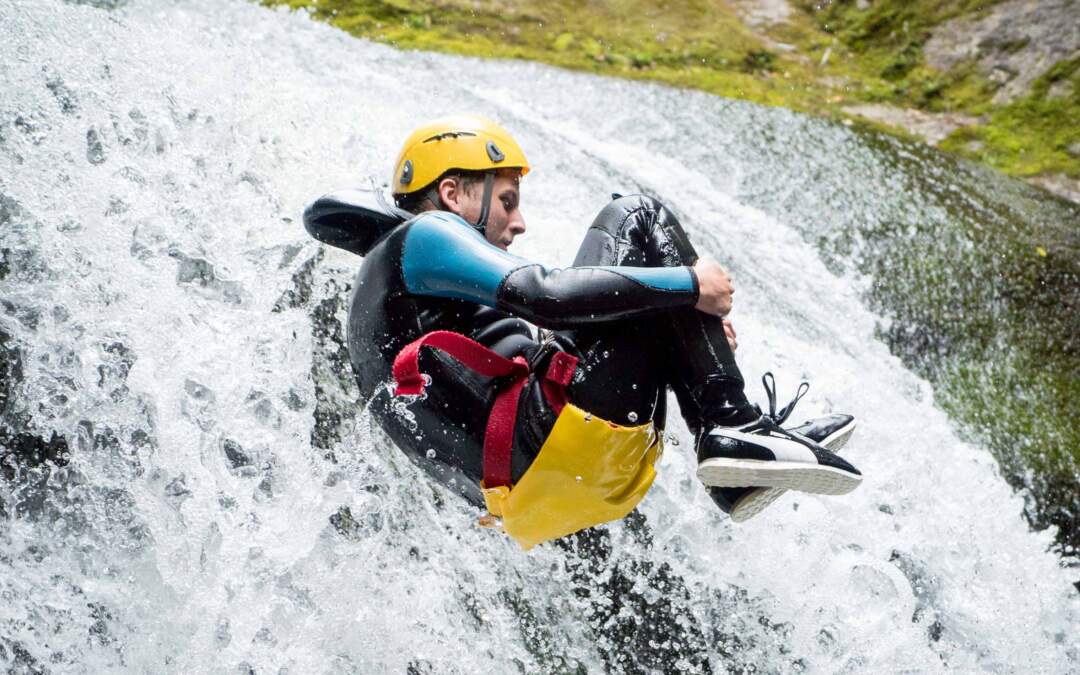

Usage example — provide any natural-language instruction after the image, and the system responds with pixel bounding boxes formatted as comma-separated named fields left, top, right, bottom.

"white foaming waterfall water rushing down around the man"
left=0, top=0, right=1080, bottom=673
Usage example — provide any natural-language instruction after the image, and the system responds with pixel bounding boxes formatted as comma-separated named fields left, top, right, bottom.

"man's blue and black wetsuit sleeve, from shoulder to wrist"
left=402, top=212, right=698, bottom=328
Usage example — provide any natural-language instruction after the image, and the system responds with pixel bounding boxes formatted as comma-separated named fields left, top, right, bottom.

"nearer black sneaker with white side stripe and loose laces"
left=698, top=373, right=863, bottom=495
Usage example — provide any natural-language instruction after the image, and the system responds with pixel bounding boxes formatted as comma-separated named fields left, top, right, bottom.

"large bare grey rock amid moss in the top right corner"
left=923, top=0, right=1080, bottom=104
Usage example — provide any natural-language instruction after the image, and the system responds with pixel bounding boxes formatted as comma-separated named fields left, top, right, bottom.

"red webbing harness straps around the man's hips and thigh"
left=393, top=330, right=578, bottom=488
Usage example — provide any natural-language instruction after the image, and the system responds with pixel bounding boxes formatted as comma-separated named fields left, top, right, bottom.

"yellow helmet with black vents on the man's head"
left=391, top=114, right=529, bottom=195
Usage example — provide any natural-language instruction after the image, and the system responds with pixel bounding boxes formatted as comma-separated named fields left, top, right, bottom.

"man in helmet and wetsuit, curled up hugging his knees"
left=305, top=116, right=862, bottom=549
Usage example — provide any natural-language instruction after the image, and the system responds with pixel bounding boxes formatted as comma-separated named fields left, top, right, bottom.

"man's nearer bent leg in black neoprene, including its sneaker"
left=570, top=197, right=861, bottom=508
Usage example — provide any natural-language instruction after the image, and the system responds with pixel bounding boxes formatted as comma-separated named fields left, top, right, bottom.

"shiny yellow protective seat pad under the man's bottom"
left=484, top=404, right=663, bottom=550
